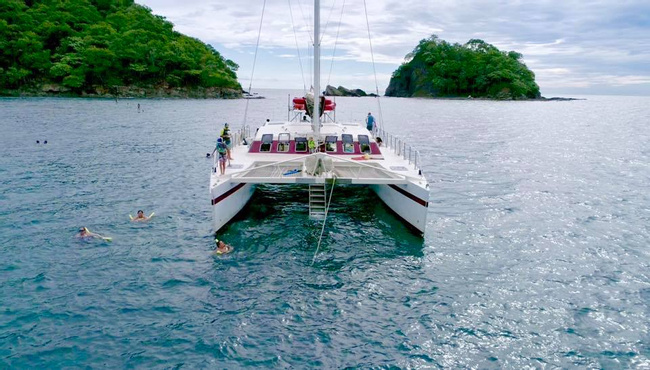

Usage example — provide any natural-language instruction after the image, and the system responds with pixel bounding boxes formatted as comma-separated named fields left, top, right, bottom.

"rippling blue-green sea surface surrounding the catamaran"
left=0, top=90, right=650, bottom=369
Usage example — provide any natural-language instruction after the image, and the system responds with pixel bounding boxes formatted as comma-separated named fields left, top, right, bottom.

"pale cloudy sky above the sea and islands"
left=137, top=0, right=650, bottom=97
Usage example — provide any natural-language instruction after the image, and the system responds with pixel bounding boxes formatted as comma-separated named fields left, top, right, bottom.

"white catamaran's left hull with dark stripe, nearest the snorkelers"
left=210, top=181, right=255, bottom=232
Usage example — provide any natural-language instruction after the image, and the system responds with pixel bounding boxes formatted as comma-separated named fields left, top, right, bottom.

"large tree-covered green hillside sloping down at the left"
left=0, top=0, right=241, bottom=95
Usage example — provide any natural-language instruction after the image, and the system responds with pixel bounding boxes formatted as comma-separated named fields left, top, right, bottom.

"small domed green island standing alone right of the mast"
left=386, top=35, right=540, bottom=99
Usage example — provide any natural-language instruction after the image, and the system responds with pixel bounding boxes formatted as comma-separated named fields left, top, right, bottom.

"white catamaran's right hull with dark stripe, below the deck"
left=371, top=184, right=429, bottom=233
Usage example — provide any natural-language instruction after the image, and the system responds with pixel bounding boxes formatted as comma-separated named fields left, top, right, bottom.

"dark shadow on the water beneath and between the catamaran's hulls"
left=219, top=185, right=424, bottom=270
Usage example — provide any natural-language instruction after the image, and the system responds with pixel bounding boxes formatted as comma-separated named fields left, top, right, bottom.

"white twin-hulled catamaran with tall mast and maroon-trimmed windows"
left=210, top=0, right=429, bottom=233
